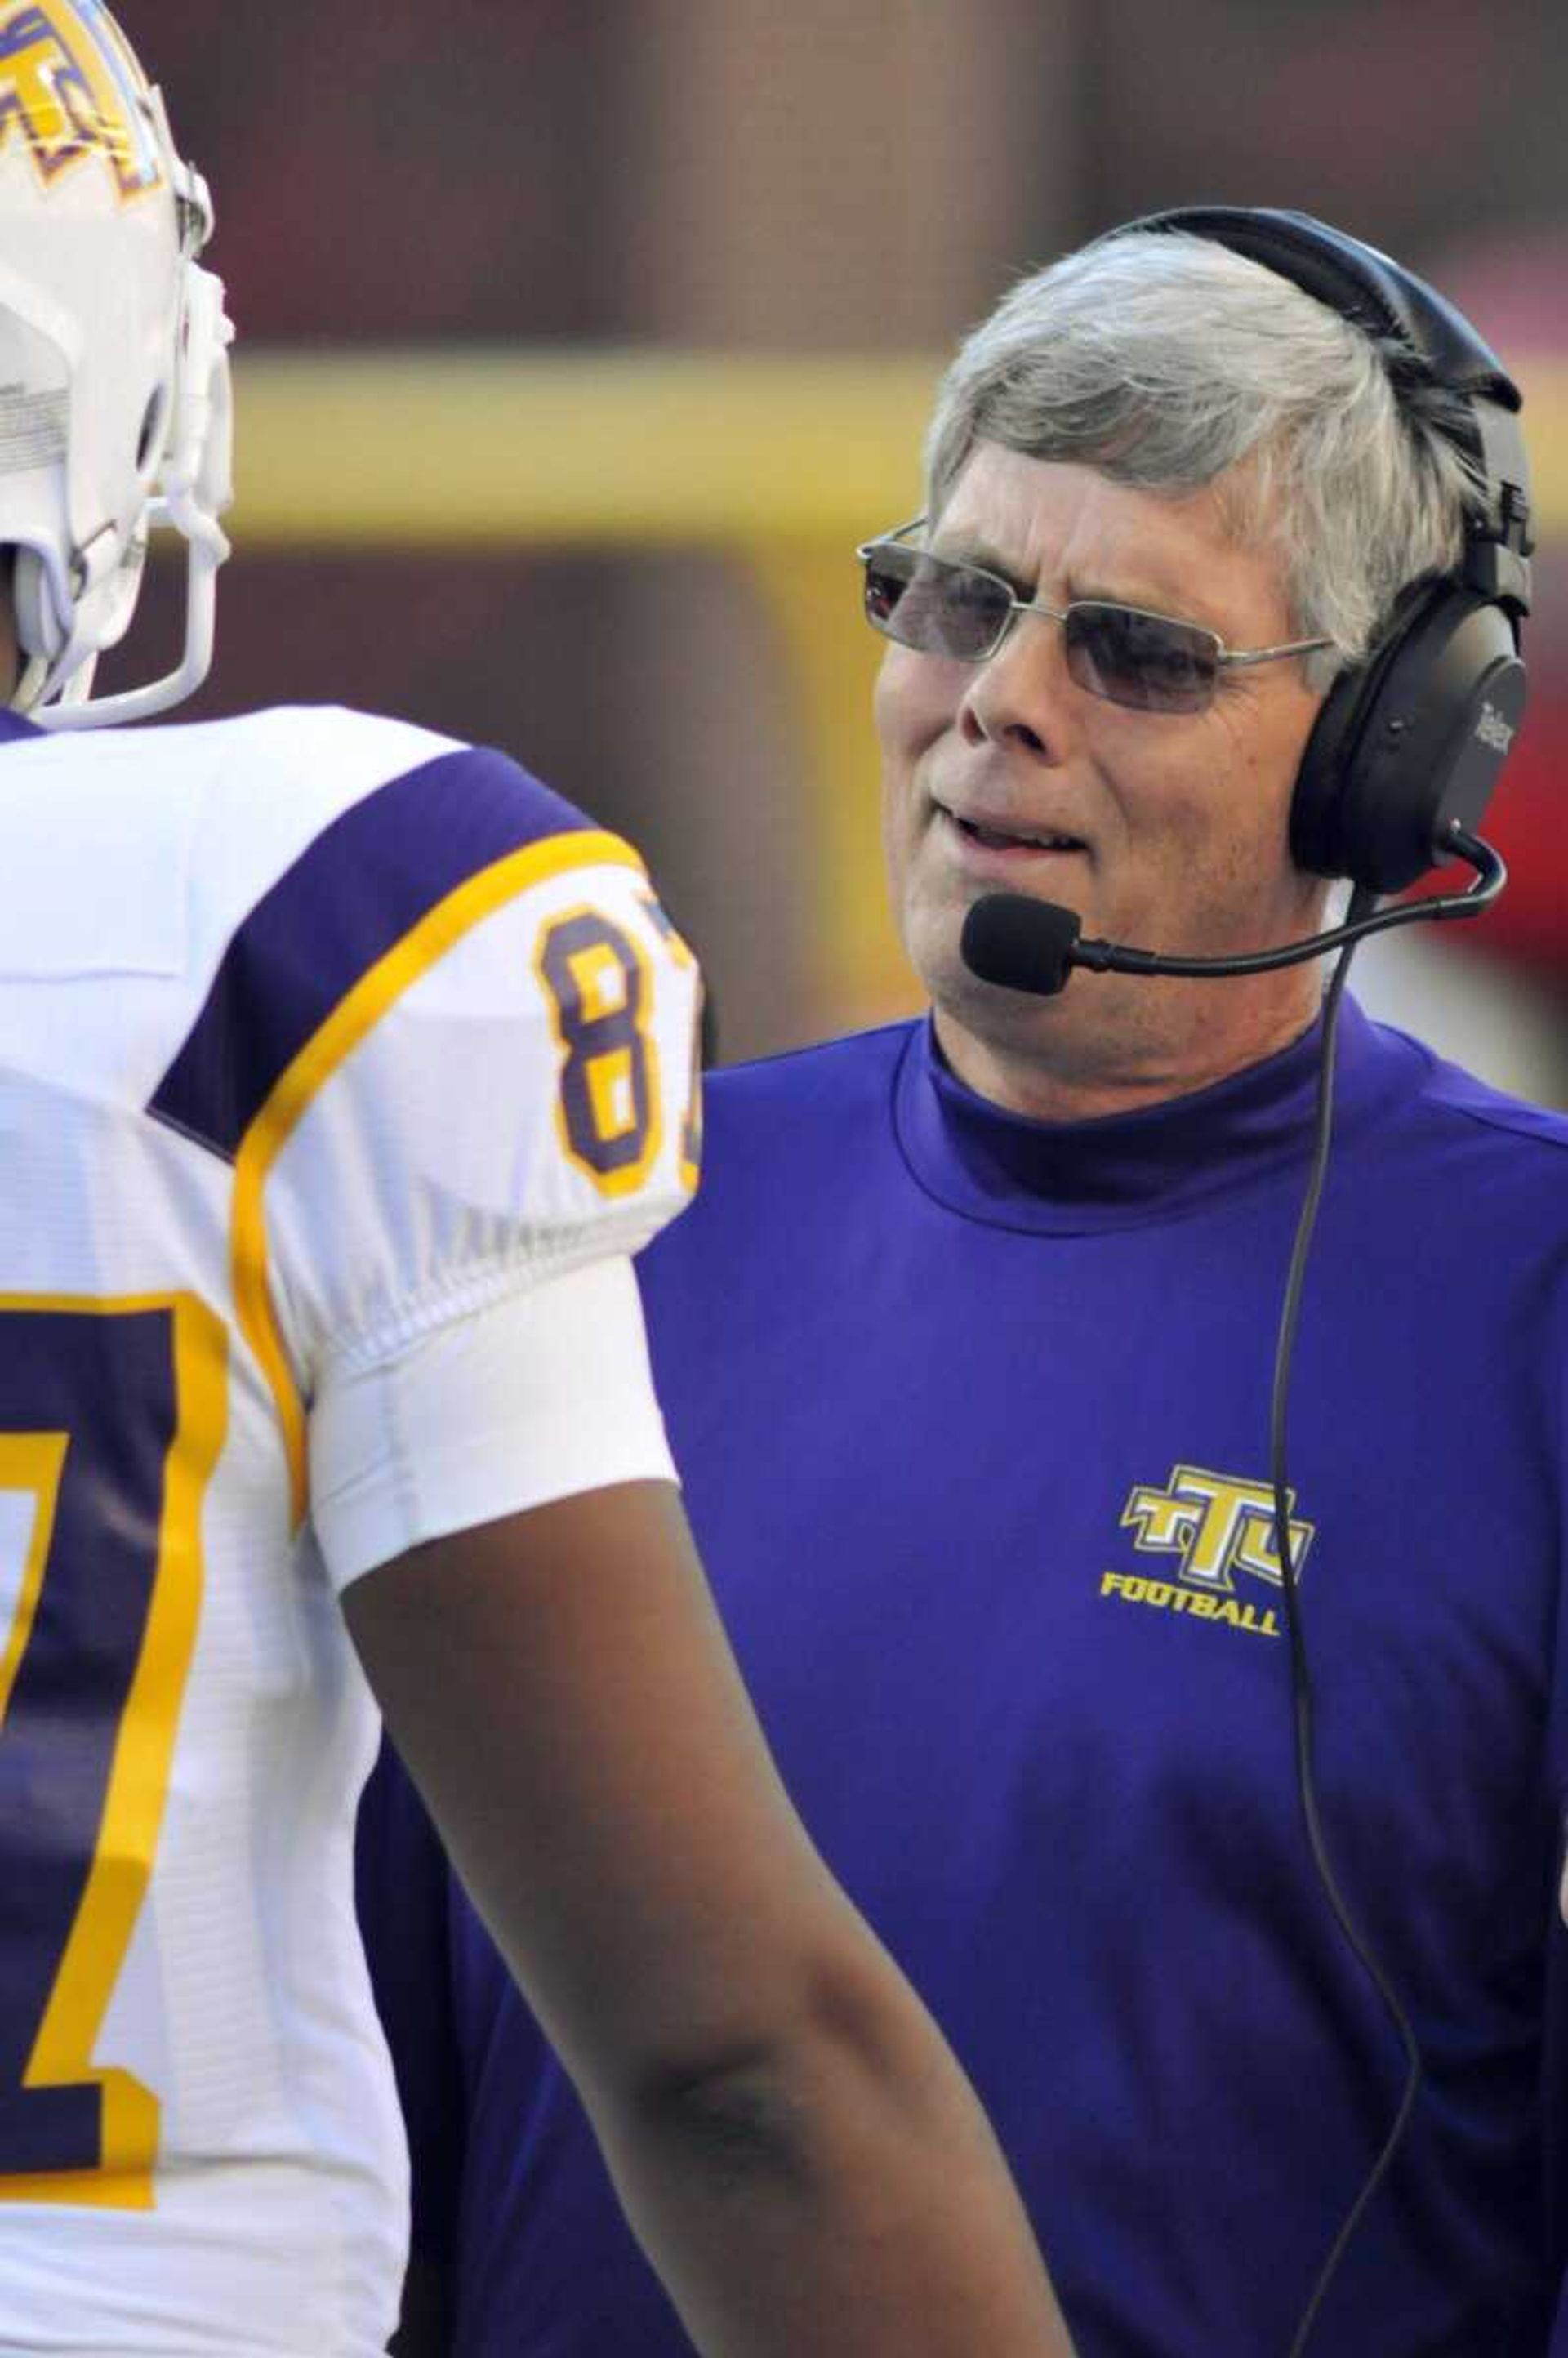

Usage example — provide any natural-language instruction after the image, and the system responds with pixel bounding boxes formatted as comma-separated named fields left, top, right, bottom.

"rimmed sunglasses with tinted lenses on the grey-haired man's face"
left=856, top=516, right=1332, bottom=712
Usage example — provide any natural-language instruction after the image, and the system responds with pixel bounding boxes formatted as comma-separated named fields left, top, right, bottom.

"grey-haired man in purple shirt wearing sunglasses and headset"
left=361, top=212, right=1568, bottom=2358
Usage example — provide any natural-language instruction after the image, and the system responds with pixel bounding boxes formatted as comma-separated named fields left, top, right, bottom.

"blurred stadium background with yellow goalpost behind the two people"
left=122, top=0, right=1568, bottom=1085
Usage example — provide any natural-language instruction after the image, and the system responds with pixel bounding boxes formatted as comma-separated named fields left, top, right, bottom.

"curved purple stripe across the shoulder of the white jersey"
left=146, top=747, right=590, bottom=1160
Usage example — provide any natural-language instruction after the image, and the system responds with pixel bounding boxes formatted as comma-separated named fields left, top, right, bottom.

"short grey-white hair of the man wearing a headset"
left=927, top=231, right=1481, bottom=686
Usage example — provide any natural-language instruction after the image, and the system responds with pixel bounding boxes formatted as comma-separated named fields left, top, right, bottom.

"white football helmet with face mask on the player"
left=0, top=0, right=234, bottom=729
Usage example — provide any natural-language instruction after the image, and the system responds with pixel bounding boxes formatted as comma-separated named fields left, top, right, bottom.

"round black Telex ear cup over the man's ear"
left=1290, top=580, right=1526, bottom=894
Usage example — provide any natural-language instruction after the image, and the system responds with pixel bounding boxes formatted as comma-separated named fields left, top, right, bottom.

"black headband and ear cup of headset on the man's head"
left=1113, top=205, right=1533, bottom=894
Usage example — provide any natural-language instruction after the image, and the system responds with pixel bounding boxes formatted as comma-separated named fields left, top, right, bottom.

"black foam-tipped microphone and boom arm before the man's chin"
left=960, top=823, right=1509, bottom=1000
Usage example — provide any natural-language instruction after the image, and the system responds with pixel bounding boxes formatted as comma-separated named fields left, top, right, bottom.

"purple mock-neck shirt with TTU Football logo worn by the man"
left=361, top=1005, right=1568, bottom=2358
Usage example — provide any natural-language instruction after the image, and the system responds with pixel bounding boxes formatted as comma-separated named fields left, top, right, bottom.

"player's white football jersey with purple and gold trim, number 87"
left=0, top=710, right=698, bottom=2358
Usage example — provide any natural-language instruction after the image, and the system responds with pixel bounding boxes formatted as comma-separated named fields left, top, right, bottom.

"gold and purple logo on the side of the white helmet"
left=0, top=0, right=163, bottom=200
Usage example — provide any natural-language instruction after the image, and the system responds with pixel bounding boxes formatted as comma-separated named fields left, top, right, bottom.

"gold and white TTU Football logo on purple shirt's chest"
left=1098, top=1467, right=1313, bottom=1637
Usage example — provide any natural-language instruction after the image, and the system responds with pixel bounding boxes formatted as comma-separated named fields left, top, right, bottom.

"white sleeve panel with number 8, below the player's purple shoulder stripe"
left=257, top=837, right=696, bottom=1391
